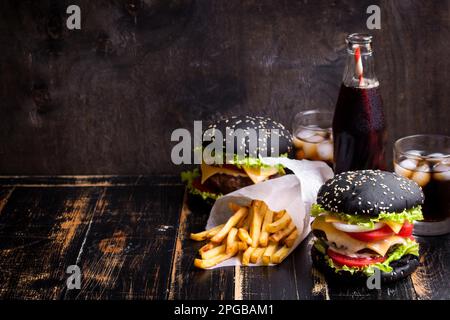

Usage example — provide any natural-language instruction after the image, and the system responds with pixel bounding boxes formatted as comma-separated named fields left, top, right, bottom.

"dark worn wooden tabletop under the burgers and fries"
left=0, top=176, right=450, bottom=299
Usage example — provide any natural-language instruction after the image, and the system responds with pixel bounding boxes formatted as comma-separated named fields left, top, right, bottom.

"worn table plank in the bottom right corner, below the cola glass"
left=412, top=235, right=450, bottom=300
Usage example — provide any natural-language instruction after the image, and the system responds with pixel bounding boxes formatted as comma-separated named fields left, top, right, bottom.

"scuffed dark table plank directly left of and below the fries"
left=168, top=192, right=234, bottom=300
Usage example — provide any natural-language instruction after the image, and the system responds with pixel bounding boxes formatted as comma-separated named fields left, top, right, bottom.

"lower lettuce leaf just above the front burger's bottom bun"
left=322, top=239, right=419, bottom=276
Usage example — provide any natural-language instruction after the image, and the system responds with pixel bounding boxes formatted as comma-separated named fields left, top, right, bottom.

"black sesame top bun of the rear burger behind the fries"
left=204, top=116, right=293, bottom=158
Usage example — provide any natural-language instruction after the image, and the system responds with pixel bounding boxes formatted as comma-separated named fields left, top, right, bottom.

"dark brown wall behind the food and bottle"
left=0, top=0, right=450, bottom=175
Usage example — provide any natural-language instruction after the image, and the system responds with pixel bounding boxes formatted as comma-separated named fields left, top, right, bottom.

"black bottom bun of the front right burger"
left=311, top=246, right=419, bottom=283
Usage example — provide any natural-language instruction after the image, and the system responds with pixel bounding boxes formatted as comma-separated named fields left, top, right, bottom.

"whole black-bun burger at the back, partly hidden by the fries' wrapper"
left=182, top=116, right=293, bottom=200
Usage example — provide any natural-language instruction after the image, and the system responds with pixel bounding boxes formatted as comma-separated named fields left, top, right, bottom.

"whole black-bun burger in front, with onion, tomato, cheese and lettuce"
left=311, top=170, right=424, bottom=282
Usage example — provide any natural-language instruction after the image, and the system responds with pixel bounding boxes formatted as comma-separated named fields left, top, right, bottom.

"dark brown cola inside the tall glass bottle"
left=333, top=84, right=386, bottom=173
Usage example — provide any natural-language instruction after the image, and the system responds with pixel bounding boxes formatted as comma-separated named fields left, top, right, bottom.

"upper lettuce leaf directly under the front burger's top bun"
left=311, top=203, right=423, bottom=228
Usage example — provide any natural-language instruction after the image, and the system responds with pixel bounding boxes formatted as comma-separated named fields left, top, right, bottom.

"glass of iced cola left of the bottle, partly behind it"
left=292, top=109, right=333, bottom=167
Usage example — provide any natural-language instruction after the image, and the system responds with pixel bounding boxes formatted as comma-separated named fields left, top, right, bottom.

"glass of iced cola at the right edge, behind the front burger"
left=394, top=134, right=450, bottom=235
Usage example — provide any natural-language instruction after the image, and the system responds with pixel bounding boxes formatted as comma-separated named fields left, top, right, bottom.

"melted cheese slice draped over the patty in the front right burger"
left=311, top=217, right=406, bottom=256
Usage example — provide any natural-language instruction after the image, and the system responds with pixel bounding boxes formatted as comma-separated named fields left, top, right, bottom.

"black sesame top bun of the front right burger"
left=317, top=170, right=424, bottom=216
